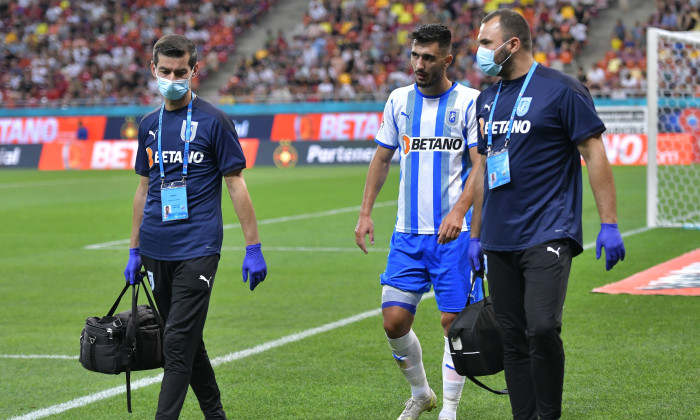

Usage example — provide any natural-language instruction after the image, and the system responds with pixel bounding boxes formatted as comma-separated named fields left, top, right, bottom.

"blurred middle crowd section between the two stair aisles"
left=220, top=0, right=607, bottom=103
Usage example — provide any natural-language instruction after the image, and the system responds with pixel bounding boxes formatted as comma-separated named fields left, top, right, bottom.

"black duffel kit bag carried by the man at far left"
left=79, top=275, right=164, bottom=413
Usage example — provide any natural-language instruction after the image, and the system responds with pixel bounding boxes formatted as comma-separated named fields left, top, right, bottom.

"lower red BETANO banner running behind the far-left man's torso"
left=39, top=139, right=260, bottom=171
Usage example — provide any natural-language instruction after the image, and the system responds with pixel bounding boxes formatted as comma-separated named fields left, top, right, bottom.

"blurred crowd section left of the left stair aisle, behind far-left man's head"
left=0, top=0, right=276, bottom=108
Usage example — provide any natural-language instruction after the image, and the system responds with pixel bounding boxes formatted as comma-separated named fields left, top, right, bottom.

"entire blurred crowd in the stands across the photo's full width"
left=0, top=0, right=700, bottom=107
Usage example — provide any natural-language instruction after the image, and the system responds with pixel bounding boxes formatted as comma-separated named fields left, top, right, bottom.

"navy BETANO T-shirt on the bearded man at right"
left=476, top=65, right=605, bottom=255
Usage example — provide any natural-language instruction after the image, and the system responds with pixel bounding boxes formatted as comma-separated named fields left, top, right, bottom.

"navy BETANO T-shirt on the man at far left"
left=135, top=96, right=246, bottom=261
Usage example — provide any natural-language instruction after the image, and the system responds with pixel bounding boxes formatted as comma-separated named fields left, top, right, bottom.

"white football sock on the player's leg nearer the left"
left=387, top=330, right=430, bottom=398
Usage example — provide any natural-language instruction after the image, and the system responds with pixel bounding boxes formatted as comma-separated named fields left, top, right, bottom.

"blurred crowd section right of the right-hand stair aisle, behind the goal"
left=577, top=0, right=700, bottom=99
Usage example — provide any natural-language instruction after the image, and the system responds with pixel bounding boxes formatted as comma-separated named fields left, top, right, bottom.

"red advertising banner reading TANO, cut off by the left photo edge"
left=0, top=116, right=107, bottom=144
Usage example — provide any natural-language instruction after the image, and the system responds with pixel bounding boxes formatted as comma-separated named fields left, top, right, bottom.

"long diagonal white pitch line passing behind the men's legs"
left=10, top=292, right=435, bottom=420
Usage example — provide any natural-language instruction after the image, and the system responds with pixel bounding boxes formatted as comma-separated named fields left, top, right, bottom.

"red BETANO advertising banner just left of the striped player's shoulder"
left=270, top=112, right=382, bottom=141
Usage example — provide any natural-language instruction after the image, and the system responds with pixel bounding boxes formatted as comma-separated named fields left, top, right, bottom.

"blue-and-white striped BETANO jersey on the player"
left=375, top=83, right=479, bottom=235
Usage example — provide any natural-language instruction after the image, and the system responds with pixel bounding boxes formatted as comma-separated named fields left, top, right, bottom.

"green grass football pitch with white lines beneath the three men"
left=0, top=165, right=700, bottom=420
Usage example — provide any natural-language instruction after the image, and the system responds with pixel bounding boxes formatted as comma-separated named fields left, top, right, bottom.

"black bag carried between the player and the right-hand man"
left=447, top=273, right=508, bottom=395
